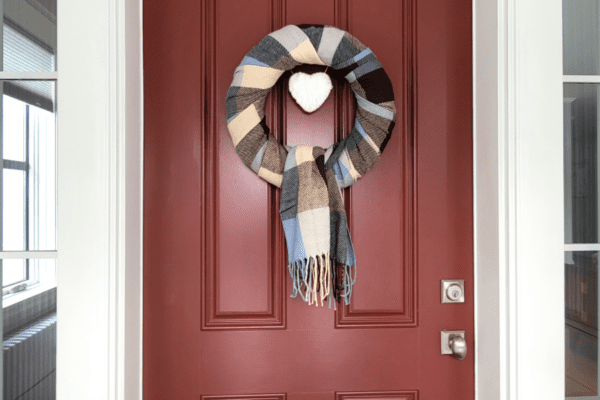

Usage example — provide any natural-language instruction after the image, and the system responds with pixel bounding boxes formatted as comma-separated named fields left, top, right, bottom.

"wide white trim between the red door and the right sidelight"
left=473, top=0, right=565, bottom=400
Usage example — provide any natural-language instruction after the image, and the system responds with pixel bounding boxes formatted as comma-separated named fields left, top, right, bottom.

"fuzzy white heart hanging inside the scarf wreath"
left=290, top=72, right=333, bottom=113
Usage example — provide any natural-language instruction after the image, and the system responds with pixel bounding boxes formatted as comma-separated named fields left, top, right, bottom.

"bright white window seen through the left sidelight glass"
left=2, top=95, right=56, bottom=296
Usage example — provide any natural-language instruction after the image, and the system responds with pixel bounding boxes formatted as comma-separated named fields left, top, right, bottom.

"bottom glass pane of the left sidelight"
left=0, top=260, right=57, bottom=400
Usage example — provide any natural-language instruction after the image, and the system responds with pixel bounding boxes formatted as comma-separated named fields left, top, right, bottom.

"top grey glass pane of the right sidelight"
left=563, top=0, right=600, bottom=75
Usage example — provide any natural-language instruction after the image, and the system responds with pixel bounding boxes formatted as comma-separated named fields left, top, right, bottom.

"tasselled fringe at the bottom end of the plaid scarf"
left=288, top=253, right=356, bottom=309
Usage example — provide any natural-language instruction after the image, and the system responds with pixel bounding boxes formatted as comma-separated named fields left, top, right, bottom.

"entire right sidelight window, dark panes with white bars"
left=563, top=0, right=600, bottom=399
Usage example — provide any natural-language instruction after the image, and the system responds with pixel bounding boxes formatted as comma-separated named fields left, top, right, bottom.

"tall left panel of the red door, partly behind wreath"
left=211, top=0, right=284, bottom=329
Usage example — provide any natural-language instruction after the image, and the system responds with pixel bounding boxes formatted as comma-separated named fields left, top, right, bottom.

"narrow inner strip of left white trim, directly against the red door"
left=110, top=0, right=144, bottom=400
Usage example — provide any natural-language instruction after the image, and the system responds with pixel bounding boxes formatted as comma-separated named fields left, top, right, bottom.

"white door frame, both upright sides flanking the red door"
left=57, top=0, right=564, bottom=400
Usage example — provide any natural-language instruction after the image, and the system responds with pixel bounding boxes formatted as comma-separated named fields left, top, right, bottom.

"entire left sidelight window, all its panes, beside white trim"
left=0, top=0, right=57, bottom=400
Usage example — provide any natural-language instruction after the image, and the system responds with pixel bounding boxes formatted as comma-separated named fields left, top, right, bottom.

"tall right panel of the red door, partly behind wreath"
left=336, top=0, right=417, bottom=328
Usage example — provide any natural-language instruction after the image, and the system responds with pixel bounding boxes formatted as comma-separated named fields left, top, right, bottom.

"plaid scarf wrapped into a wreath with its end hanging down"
left=227, top=25, right=396, bottom=307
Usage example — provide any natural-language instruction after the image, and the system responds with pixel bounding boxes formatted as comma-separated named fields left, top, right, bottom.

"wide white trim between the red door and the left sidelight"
left=57, top=0, right=143, bottom=400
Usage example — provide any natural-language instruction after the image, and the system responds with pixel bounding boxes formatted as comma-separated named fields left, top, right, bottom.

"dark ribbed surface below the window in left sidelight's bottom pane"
left=2, top=312, right=56, bottom=400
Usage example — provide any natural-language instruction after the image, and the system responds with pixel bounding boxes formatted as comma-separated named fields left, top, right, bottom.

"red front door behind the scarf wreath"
left=143, top=0, right=474, bottom=400
